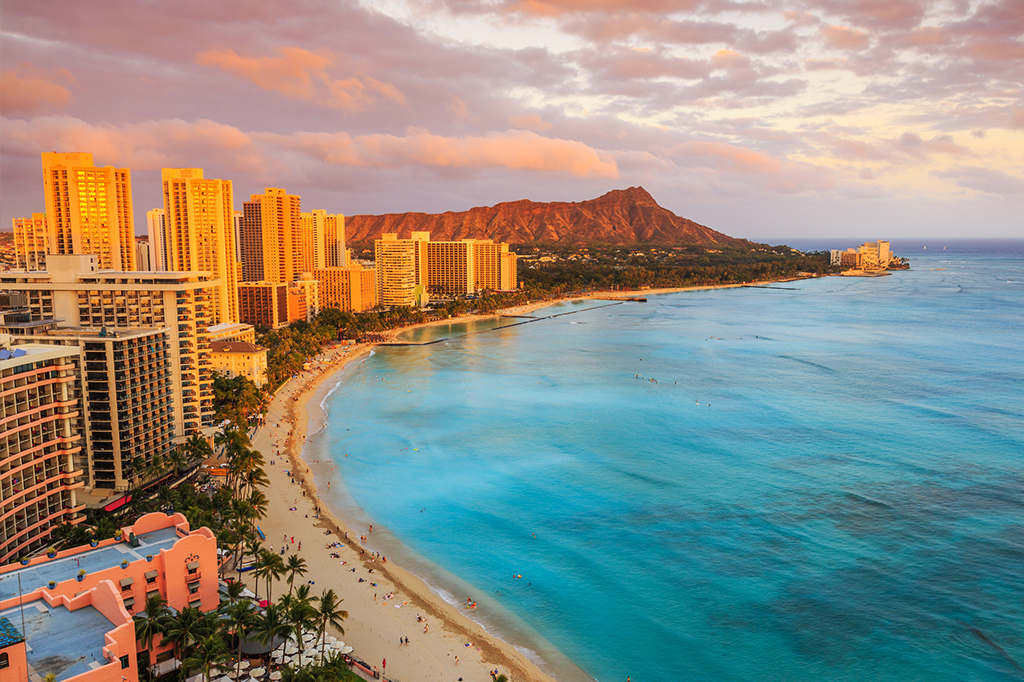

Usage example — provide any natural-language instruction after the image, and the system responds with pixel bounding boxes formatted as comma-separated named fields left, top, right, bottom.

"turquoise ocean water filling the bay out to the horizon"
left=307, top=242, right=1024, bottom=682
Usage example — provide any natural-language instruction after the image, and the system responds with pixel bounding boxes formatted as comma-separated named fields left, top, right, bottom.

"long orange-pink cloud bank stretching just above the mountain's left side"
left=255, top=128, right=618, bottom=178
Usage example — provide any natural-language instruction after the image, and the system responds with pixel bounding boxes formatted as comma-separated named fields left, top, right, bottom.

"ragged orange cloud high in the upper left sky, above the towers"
left=196, top=46, right=406, bottom=112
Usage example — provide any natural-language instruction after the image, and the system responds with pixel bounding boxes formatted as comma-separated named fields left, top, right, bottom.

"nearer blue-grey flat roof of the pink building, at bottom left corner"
left=0, top=599, right=116, bottom=680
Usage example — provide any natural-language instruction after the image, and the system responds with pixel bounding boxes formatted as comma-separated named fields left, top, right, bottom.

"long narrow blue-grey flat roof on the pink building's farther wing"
left=0, top=526, right=178, bottom=601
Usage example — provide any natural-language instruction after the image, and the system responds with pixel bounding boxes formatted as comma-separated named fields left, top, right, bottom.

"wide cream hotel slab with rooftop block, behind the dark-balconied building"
left=0, top=254, right=220, bottom=438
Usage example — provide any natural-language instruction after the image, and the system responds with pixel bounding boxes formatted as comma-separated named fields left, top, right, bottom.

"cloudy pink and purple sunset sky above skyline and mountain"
left=0, top=0, right=1024, bottom=240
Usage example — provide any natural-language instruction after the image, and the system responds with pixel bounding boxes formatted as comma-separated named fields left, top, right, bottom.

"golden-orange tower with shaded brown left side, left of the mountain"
left=241, top=187, right=305, bottom=283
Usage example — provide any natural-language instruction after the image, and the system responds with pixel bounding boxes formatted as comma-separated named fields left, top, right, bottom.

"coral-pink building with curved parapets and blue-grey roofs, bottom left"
left=0, top=513, right=220, bottom=682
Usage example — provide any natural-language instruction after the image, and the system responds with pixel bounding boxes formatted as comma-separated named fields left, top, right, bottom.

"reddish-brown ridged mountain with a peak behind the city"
left=345, top=187, right=749, bottom=246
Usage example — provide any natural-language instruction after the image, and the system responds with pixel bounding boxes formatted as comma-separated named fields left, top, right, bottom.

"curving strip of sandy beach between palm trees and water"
left=240, top=278, right=806, bottom=682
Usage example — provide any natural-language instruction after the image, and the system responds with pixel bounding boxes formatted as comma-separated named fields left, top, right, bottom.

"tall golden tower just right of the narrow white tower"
left=162, top=168, right=239, bottom=324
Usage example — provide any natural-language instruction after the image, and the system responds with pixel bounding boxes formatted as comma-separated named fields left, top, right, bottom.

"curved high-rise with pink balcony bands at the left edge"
left=0, top=337, right=85, bottom=557
